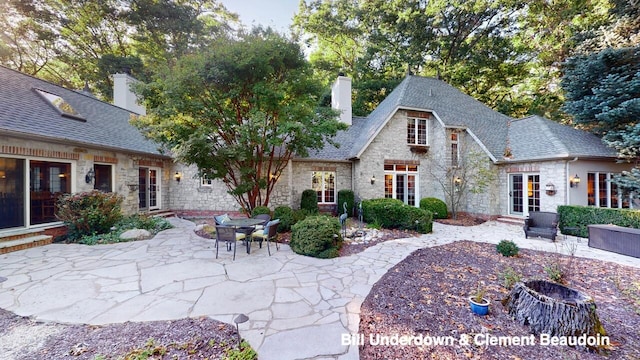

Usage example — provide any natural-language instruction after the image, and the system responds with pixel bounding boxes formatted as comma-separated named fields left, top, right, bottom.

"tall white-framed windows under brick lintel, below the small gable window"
left=384, top=164, right=419, bottom=206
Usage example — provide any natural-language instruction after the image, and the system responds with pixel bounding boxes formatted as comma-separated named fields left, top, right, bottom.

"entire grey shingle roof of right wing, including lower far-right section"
left=310, top=75, right=616, bottom=161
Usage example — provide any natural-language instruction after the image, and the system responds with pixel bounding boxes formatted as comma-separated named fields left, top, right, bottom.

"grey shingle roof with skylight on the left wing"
left=0, top=66, right=168, bottom=155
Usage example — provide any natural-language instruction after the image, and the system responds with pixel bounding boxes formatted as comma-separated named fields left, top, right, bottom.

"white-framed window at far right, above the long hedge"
left=587, top=172, right=631, bottom=209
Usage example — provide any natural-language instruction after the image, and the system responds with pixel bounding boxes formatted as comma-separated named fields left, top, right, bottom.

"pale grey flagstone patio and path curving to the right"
left=0, top=218, right=640, bottom=360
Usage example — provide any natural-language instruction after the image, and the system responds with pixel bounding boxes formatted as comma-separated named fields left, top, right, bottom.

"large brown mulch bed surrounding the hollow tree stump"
left=359, top=241, right=640, bottom=359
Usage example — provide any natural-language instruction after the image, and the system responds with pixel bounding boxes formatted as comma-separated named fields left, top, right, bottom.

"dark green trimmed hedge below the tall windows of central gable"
left=362, top=198, right=433, bottom=234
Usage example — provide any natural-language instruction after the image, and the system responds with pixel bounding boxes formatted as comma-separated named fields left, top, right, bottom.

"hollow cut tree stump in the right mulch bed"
left=502, top=280, right=607, bottom=351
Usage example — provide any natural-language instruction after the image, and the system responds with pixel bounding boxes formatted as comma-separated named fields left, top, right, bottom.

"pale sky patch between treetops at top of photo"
left=220, top=0, right=300, bottom=33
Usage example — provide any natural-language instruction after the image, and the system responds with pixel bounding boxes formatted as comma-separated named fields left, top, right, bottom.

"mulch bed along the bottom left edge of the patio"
left=0, top=309, right=245, bottom=360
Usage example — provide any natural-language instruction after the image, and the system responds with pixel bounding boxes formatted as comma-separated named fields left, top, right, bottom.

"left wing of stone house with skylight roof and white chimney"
left=0, top=66, right=173, bottom=249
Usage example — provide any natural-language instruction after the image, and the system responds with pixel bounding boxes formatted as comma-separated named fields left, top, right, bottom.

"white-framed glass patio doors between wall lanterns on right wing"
left=509, top=174, right=540, bottom=216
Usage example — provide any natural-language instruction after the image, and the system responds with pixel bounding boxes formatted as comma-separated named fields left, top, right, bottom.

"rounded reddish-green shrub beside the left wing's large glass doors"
left=56, top=190, right=123, bottom=240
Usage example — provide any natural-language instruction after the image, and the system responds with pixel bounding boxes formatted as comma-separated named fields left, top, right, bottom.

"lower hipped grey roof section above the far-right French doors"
left=509, top=115, right=617, bottom=160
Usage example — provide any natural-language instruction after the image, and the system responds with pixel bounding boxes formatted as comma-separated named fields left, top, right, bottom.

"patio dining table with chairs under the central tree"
left=214, top=214, right=280, bottom=260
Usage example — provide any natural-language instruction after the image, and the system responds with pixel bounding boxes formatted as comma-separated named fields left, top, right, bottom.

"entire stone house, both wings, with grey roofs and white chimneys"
left=0, top=66, right=631, bottom=250
